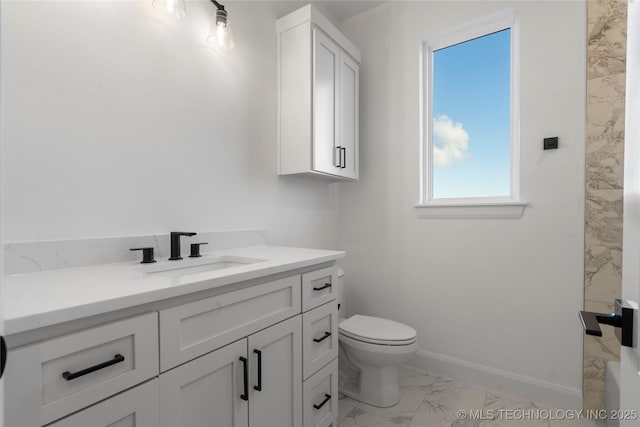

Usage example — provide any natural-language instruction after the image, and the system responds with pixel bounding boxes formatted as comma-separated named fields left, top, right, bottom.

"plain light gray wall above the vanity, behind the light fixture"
left=0, top=0, right=338, bottom=248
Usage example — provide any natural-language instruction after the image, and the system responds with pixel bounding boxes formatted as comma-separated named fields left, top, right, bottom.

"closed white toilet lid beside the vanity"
left=338, top=314, right=417, bottom=345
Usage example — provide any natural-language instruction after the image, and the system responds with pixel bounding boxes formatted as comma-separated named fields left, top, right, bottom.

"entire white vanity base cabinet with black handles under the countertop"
left=6, top=263, right=338, bottom=427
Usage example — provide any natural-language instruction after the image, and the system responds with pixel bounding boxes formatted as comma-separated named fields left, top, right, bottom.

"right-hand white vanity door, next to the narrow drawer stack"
left=249, top=316, right=302, bottom=427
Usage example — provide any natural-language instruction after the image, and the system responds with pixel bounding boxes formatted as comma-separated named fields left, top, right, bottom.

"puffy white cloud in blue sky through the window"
left=433, top=115, right=469, bottom=168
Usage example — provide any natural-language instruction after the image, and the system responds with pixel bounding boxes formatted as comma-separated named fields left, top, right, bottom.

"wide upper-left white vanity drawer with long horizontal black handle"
left=6, top=313, right=158, bottom=426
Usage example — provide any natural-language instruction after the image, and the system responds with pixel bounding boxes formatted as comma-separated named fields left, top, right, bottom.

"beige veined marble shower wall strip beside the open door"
left=582, top=0, right=627, bottom=409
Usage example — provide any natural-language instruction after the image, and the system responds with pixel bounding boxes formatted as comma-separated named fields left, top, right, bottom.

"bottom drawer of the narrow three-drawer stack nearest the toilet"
left=302, top=359, right=338, bottom=427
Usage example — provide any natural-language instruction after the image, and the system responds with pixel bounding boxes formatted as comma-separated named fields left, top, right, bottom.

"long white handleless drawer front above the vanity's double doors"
left=160, top=275, right=300, bottom=372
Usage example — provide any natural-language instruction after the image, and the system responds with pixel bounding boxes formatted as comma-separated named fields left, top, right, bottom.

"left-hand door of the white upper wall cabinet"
left=312, top=28, right=340, bottom=175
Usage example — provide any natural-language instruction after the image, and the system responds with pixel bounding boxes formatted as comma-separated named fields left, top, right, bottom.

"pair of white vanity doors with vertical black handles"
left=160, top=316, right=302, bottom=427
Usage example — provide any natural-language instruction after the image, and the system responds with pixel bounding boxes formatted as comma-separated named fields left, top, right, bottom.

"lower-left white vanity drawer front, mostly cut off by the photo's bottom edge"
left=49, top=379, right=158, bottom=427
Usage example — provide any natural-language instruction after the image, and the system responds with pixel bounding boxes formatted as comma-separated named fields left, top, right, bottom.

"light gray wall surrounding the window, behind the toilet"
left=340, top=1, right=586, bottom=407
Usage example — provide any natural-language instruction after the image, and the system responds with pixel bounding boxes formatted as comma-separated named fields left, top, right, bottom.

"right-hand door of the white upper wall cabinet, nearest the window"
left=337, top=52, right=360, bottom=179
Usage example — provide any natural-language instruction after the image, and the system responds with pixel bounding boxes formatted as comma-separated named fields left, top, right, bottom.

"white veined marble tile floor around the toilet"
left=338, top=368, right=600, bottom=427
